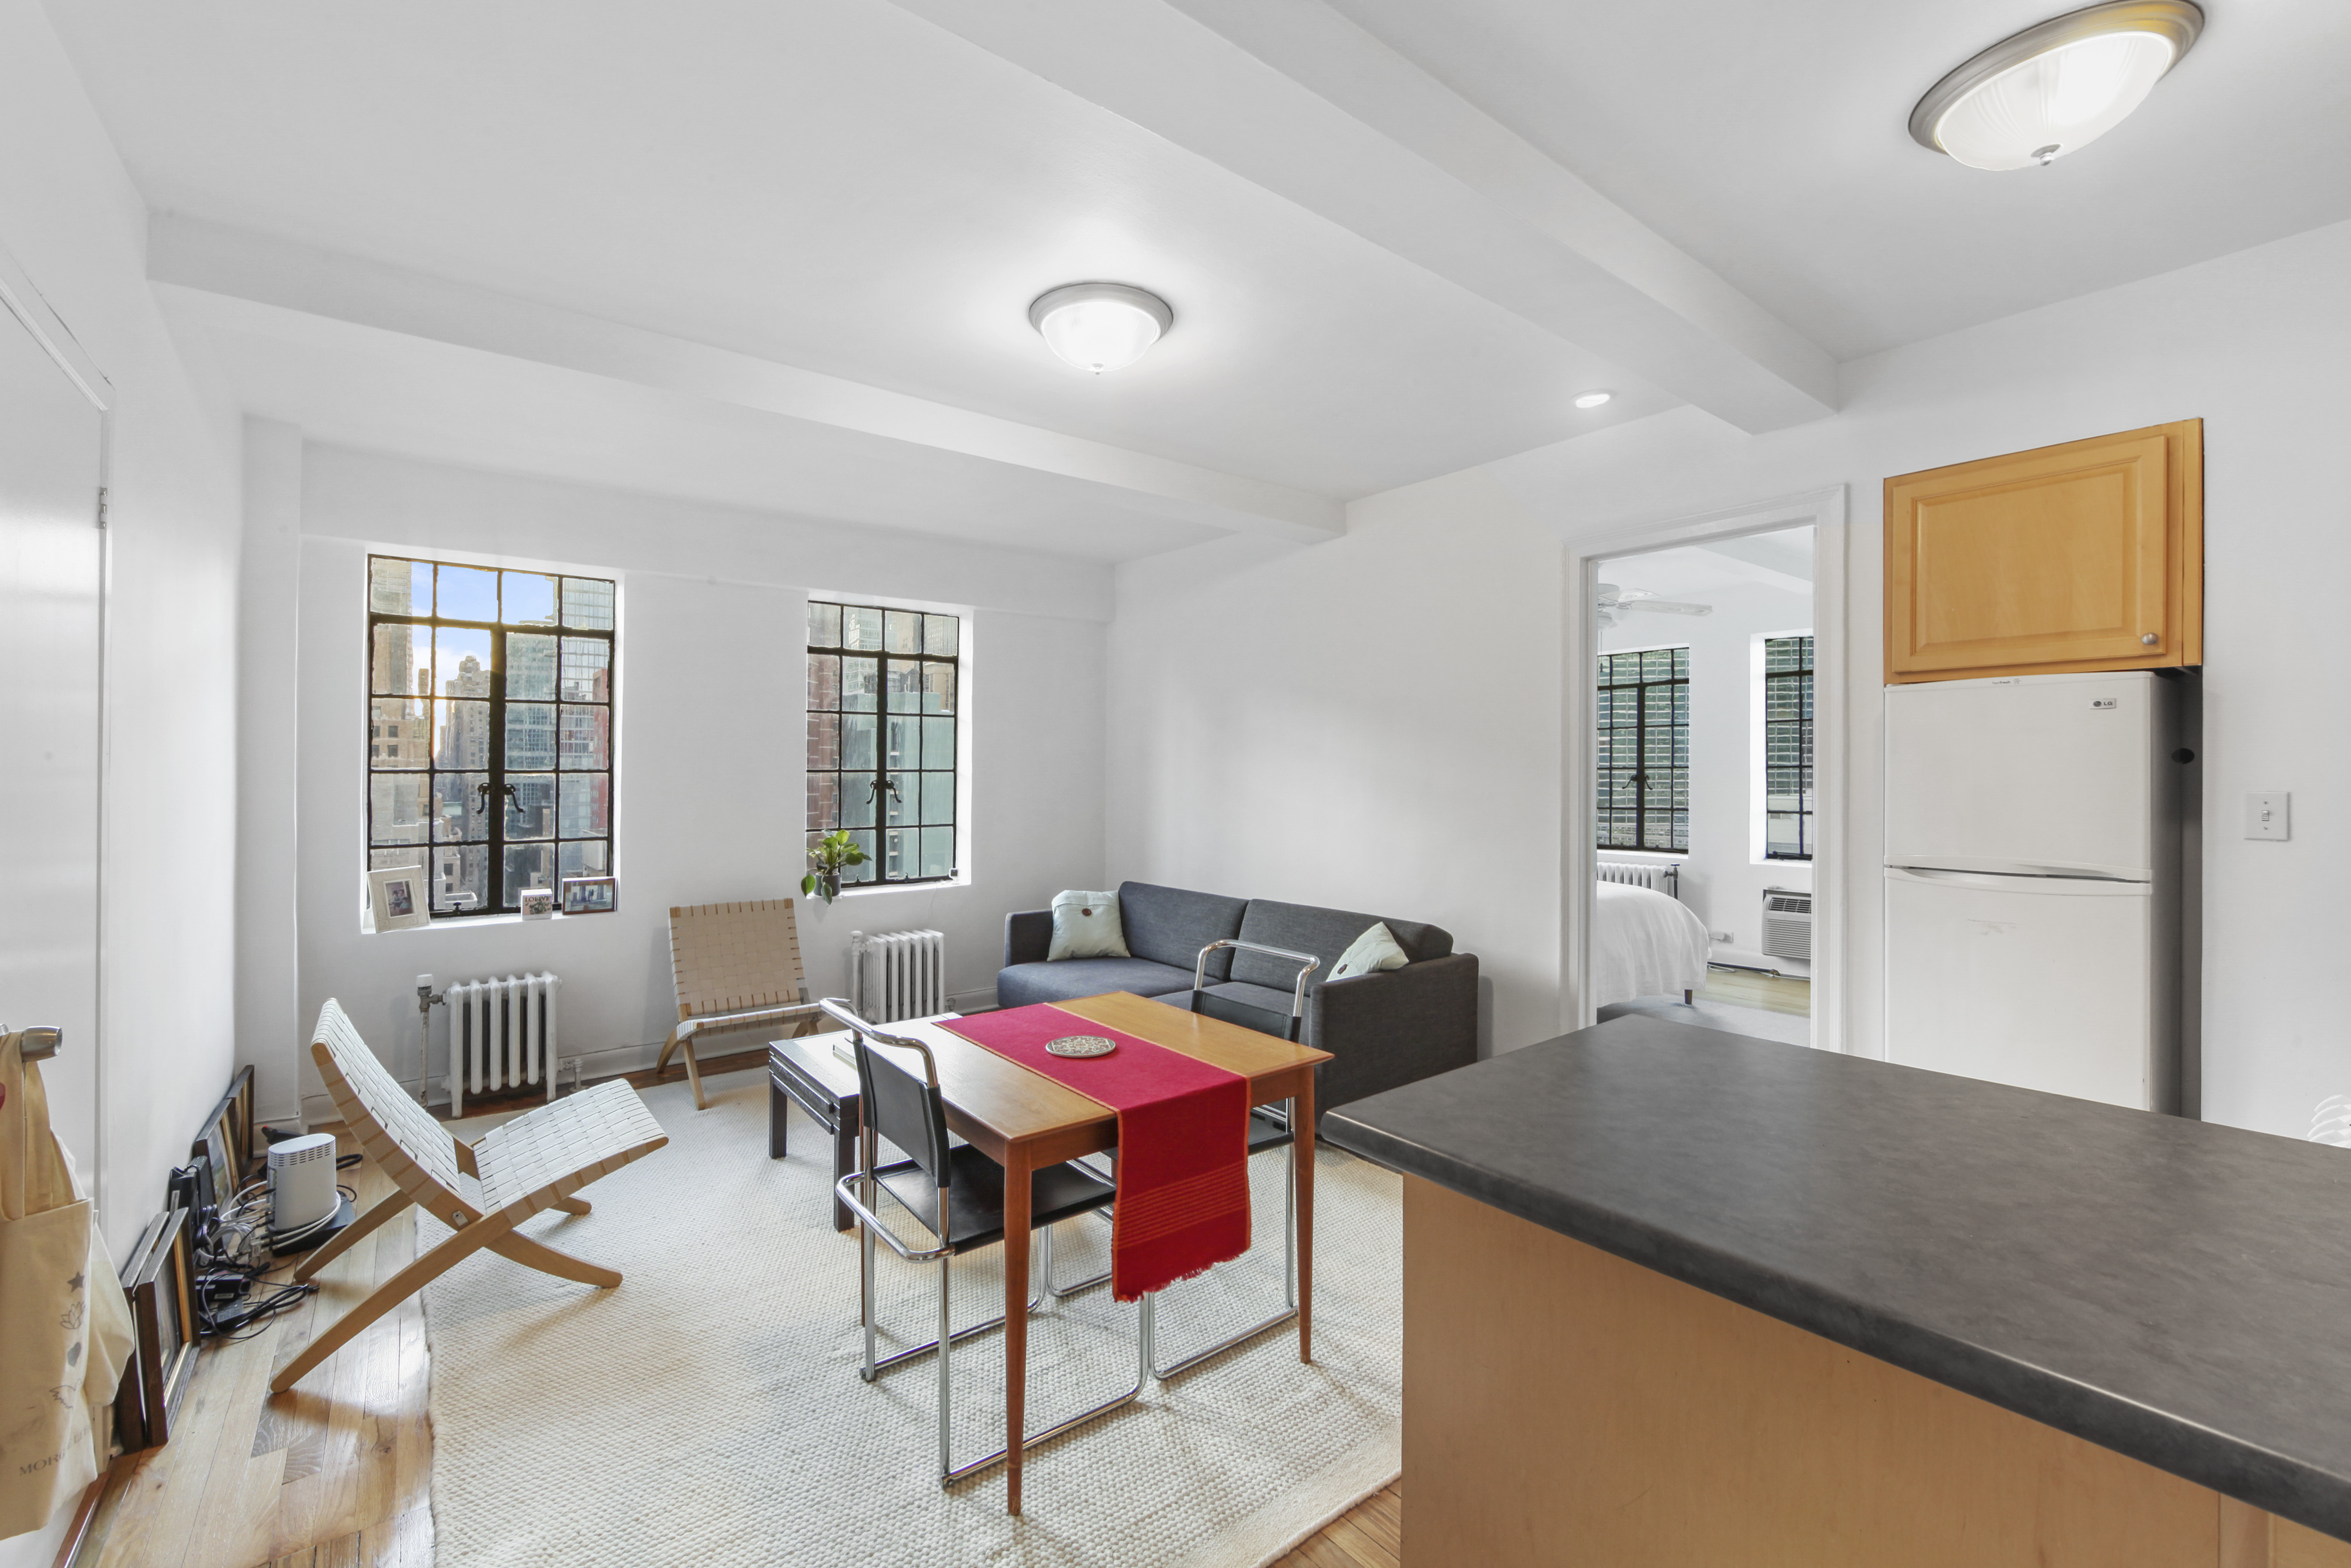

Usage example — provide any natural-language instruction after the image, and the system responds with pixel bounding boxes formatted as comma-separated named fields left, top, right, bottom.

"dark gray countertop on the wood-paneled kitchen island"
left=1324, top=1015, right=2351, bottom=1540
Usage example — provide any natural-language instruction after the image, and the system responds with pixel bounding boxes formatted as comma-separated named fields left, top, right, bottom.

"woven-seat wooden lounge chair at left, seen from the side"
left=270, top=997, right=670, bottom=1394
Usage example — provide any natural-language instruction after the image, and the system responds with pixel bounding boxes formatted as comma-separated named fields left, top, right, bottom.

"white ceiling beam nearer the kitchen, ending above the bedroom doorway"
left=893, top=0, right=1836, bottom=430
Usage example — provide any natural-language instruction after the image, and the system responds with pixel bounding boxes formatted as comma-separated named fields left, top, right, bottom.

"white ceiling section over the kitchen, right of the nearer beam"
left=1331, top=0, right=2351, bottom=360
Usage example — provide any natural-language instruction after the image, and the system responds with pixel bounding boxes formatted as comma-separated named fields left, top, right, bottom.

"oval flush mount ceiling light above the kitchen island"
left=1911, top=0, right=2203, bottom=169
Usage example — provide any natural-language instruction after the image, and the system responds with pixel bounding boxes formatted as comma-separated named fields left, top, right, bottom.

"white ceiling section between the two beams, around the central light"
left=56, top=0, right=1665, bottom=510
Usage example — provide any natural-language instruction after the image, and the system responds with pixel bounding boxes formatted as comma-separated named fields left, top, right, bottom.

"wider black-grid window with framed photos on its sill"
left=367, top=555, right=618, bottom=919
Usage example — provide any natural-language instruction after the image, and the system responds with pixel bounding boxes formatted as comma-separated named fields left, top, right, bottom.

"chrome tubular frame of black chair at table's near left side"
left=818, top=997, right=1152, bottom=1490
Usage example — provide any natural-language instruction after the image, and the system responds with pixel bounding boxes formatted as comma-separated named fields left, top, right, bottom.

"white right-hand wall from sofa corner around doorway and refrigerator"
left=1110, top=211, right=2351, bottom=1135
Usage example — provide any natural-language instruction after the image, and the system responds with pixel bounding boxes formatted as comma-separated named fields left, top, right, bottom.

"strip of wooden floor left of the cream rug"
left=80, top=1129, right=432, bottom=1568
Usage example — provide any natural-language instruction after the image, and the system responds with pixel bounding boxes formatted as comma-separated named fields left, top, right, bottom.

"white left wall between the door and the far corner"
left=0, top=0, right=237, bottom=1568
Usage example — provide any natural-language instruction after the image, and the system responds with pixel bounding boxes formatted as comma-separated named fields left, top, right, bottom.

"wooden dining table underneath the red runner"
left=893, top=992, right=1331, bottom=1514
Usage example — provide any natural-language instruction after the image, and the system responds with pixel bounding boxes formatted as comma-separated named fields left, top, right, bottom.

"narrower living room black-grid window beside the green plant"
left=809, top=599, right=961, bottom=884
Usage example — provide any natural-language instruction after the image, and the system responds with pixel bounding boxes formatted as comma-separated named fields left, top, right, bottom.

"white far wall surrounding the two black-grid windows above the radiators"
left=254, top=447, right=1110, bottom=1114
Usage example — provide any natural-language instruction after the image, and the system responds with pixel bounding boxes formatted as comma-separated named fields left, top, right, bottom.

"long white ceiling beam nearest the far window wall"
left=148, top=214, right=1347, bottom=543
